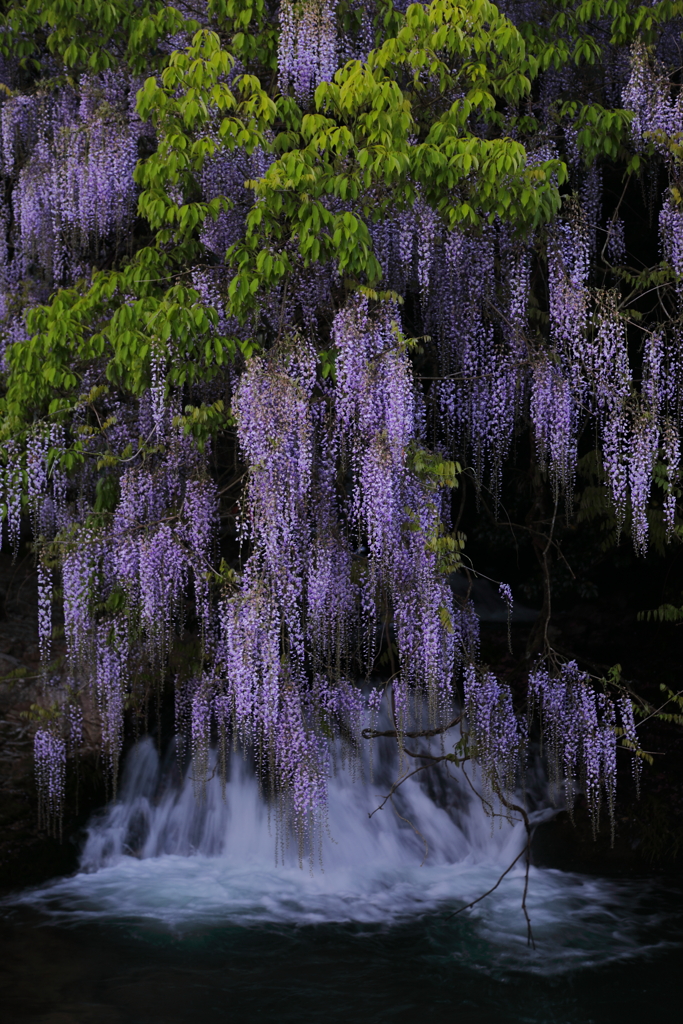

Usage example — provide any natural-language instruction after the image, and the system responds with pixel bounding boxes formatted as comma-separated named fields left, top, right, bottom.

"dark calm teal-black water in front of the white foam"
left=0, top=872, right=683, bottom=1024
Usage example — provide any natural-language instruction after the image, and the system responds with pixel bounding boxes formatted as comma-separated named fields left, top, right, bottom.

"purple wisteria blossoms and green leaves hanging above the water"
left=0, top=0, right=683, bottom=837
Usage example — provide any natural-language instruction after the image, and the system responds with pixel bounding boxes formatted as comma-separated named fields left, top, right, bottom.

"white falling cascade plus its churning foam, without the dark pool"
left=7, top=738, right=675, bottom=972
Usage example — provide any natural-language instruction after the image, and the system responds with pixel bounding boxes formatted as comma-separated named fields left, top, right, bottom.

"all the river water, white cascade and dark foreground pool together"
left=0, top=739, right=683, bottom=1024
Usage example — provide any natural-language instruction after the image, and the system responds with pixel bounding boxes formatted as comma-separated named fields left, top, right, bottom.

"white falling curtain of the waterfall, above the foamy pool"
left=81, top=737, right=525, bottom=872
